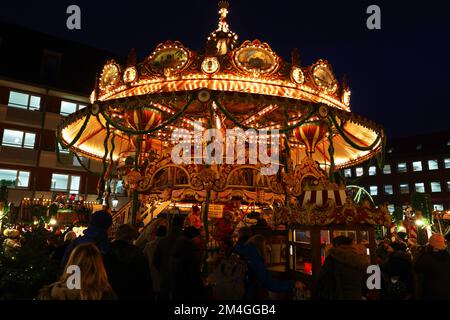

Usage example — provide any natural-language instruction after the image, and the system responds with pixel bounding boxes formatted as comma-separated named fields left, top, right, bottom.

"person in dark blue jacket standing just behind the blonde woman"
left=61, top=210, right=112, bottom=267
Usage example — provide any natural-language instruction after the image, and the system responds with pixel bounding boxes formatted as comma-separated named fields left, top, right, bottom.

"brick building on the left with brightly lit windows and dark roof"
left=0, top=24, right=120, bottom=206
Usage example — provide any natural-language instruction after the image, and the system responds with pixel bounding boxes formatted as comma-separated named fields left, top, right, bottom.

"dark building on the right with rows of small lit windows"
left=343, top=131, right=450, bottom=211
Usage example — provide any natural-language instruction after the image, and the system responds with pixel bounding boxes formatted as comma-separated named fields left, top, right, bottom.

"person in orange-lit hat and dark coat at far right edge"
left=414, top=234, right=450, bottom=300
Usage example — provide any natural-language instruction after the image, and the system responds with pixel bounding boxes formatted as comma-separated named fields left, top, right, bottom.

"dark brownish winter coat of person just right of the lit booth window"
left=317, top=246, right=369, bottom=300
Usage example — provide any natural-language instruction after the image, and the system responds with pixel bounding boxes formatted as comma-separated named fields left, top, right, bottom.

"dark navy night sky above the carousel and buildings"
left=0, top=0, right=450, bottom=138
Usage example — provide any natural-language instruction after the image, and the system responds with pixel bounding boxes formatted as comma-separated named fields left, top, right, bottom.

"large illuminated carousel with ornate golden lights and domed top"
left=57, top=1, right=390, bottom=288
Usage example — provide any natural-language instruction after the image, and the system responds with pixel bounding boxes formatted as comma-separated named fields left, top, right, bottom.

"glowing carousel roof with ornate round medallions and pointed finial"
left=58, top=1, right=384, bottom=168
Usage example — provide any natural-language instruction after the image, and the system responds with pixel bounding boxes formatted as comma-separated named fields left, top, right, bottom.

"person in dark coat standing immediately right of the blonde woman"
left=105, top=224, right=153, bottom=300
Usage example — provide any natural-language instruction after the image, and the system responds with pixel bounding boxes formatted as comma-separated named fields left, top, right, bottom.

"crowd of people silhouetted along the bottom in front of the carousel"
left=5, top=207, right=450, bottom=301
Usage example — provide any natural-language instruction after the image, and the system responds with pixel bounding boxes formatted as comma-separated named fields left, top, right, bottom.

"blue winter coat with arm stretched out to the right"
left=235, top=243, right=294, bottom=300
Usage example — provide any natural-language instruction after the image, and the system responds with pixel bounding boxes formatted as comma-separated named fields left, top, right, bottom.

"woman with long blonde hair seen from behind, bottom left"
left=38, top=243, right=117, bottom=300
